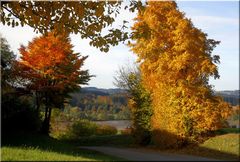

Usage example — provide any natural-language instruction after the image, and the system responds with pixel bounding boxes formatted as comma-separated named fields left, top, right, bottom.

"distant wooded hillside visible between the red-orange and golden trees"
left=69, top=88, right=130, bottom=120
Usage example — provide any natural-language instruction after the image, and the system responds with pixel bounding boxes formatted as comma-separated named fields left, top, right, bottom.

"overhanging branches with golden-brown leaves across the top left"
left=1, top=1, right=142, bottom=52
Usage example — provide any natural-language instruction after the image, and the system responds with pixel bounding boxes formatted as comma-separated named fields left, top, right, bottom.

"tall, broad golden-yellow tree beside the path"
left=130, top=1, right=230, bottom=147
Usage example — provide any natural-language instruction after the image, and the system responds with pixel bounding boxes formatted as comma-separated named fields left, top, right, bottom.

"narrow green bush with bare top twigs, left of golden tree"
left=115, top=64, right=152, bottom=145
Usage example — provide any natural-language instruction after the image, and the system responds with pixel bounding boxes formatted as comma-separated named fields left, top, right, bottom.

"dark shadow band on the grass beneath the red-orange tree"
left=1, top=133, right=123, bottom=161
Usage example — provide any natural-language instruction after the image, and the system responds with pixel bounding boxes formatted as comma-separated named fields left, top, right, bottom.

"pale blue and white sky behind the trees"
left=0, top=1, right=239, bottom=91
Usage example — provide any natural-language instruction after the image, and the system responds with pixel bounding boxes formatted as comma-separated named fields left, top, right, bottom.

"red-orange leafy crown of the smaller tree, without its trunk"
left=16, top=32, right=89, bottom=91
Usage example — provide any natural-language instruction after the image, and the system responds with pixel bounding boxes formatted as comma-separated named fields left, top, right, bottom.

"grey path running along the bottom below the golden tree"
left=80, top=146, right=218, bottom=161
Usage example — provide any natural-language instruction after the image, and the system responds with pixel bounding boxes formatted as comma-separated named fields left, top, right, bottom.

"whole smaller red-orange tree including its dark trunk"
left=18, top=32, right=91, bottom=133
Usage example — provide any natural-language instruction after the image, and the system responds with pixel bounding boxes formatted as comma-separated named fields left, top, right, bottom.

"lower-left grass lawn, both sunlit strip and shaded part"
left=1, top=134, right=124, bottom=161
